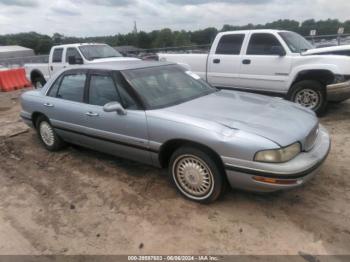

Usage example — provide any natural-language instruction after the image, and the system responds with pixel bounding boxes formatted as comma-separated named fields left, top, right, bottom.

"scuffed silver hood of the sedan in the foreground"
left=165, top=91, right=318, bottom=147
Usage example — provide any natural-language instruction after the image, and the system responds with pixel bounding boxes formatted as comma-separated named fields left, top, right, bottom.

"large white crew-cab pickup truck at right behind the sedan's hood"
left=158, top=30, right=350, bottom=114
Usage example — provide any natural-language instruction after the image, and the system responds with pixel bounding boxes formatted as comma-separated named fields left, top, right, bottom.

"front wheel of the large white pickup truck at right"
left=287, top=80, right=327, bottom=116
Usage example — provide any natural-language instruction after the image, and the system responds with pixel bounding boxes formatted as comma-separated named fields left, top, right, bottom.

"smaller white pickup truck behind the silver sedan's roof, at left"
left=24, top=43, right=139, bottom=88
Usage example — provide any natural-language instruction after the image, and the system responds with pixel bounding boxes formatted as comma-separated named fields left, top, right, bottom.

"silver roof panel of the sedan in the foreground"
left=66, top=60, right=176, bottom=71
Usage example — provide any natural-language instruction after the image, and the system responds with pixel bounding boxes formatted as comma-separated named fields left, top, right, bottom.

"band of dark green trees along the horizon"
left=0, top=19, right=350, bottom=54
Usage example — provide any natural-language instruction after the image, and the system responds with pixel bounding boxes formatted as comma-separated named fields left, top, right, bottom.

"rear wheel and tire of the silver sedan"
left=35, top=116, right=66, bottom=151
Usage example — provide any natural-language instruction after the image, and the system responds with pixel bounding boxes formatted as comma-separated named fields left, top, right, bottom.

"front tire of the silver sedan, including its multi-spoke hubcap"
left=169, top=147, right=226, bottom=204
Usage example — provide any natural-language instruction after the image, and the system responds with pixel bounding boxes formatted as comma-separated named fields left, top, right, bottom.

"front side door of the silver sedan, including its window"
left=85, top=70, right=151, bottom=163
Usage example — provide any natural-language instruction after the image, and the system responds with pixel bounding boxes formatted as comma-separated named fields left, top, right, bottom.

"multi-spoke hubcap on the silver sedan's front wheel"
left=173, top=155, right=214, bottom=200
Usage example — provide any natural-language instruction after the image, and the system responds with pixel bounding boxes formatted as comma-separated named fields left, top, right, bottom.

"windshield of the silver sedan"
left=123, top=65, right=216, bottom=109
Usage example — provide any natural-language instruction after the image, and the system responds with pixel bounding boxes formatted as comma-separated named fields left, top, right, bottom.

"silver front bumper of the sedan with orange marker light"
left=222, top=126, right=330, bottom=192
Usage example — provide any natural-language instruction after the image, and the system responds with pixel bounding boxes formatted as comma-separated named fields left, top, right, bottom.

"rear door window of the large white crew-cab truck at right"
left=215, top=34, right=245, bottom=55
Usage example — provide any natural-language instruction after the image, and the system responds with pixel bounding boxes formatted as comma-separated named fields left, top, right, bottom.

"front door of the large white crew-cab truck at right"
left=240, top=33, right=291, bottom=93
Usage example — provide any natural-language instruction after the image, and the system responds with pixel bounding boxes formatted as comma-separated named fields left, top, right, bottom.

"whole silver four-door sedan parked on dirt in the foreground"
left=21, top=61, right=330, bottom=203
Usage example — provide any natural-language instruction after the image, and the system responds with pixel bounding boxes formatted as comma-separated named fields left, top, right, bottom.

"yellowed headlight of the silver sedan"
left=254, top=143, right=301, bottom=163
